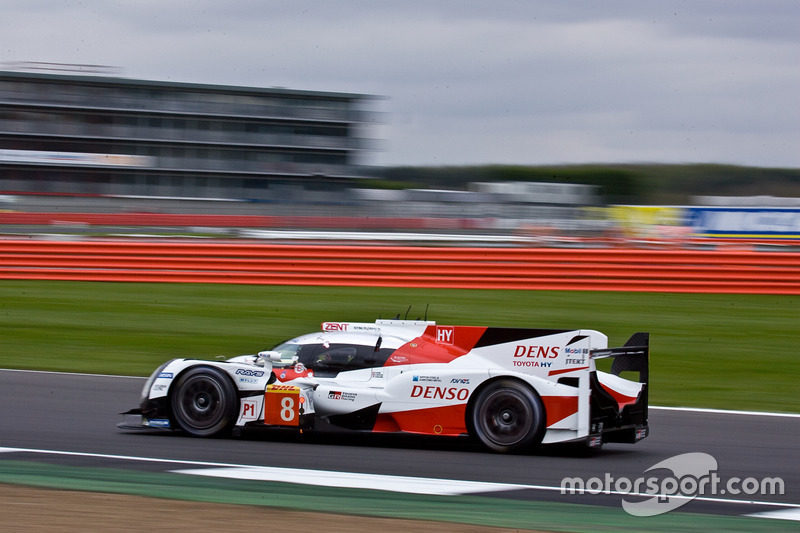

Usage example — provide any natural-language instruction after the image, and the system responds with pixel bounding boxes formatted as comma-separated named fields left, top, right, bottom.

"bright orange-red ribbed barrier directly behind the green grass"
left=0, top=240, right=800, bottom=294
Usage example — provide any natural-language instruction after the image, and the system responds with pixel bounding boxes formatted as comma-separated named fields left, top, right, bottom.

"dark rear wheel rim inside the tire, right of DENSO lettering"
left=478, top=389, right=534, bottom=446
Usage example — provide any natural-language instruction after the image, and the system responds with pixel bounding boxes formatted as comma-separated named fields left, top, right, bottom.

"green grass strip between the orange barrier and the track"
left=0, top=281, right=800, bottom=412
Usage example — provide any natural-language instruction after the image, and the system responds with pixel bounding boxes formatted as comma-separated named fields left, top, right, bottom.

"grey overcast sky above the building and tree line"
left=0, top=0, right=800, bottom=168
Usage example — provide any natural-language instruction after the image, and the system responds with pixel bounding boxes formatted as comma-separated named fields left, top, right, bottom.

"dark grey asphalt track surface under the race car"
left=0, top=370, right=800, bottom=519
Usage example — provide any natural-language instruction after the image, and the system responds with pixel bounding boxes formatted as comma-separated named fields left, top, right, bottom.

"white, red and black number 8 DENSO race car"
left=120, top=320, right=649, bottom=452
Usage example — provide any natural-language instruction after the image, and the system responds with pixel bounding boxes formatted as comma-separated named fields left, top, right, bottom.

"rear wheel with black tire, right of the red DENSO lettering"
left=468, top=379, right=545, bottom=453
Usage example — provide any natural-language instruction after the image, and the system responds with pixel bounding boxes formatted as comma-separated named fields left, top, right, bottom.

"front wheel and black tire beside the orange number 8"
left=170, top=366, right=237, bottom=437
